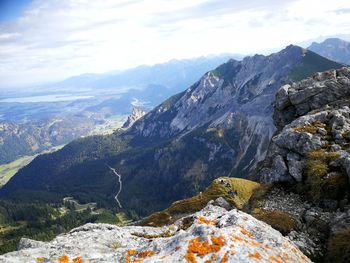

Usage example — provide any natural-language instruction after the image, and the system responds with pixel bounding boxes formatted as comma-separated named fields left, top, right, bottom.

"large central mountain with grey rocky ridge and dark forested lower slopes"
left=0, top=46, right=341, bottom=218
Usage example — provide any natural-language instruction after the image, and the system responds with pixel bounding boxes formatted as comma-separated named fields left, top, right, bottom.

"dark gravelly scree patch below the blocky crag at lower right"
left=261, top=188, right=350, bottom=259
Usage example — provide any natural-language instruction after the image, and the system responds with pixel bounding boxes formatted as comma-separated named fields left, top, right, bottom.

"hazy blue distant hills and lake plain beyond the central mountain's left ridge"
left=0, top=55, right=232, bottom=164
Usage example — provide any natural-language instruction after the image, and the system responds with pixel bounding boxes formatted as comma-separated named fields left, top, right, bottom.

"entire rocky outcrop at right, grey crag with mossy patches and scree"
left=250, top=68, right=350, bottom=262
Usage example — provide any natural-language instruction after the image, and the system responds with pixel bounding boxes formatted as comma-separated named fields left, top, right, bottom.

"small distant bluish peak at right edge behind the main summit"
left=308, top=38, right=350, bottom=65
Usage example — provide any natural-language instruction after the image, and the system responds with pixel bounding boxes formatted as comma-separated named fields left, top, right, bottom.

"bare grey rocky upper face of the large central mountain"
left=130, top=46, right=306, bottom=176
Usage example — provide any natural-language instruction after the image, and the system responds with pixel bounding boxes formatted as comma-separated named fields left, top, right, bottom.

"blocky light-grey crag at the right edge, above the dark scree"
left=260, top=68, right=350, bottom=182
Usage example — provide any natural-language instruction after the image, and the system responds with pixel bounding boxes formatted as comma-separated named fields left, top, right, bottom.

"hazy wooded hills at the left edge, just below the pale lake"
left=0, top=116, right=97, bottom=164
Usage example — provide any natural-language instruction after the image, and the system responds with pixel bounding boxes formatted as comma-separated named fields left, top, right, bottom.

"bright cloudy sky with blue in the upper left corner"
left=0, top=0, right=350, bottom=89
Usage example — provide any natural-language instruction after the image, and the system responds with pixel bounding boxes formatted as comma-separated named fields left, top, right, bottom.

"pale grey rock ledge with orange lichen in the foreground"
left=0, top=203, right=311, bottom=263
